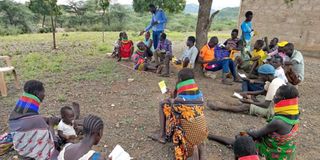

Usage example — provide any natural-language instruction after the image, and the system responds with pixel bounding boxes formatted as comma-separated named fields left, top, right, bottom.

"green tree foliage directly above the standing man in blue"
left=133, top=0, right=186, bottom=13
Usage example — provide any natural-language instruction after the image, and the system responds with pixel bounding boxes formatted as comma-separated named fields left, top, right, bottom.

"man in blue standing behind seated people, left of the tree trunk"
left=140, top=4, right=167, bottom=48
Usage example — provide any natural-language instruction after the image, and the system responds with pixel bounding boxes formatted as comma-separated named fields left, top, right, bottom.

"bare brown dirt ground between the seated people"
left=0, top=41, right=320, bottom=160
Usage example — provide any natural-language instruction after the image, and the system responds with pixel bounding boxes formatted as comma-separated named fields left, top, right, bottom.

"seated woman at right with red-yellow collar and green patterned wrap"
left=208, top=85, right=300, bottom=160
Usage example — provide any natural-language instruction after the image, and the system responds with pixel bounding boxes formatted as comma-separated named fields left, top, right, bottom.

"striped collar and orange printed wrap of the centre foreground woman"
left=163, top=79, right=208, bottom=160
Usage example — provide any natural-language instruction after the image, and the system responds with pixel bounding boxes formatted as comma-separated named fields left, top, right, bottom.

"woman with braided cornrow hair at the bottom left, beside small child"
left=58, top=115, right=105, bottom=160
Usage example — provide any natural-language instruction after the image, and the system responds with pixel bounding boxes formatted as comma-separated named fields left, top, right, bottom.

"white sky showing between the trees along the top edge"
left=15, top=0, right=241, bottom=10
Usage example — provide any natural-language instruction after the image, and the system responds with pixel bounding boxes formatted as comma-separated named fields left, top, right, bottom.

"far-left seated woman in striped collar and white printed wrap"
left=9, top=80, right=59, bottom=160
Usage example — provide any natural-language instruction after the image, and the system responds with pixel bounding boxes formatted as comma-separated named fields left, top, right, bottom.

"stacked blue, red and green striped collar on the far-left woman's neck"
left=15, top=93, right=41, bottom=113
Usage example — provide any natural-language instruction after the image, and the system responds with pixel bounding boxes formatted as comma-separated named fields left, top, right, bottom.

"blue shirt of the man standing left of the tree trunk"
left=145, top=9, right=167, bottom=31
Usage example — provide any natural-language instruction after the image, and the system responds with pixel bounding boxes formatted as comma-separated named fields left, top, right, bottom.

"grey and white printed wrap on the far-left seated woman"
left=9, top=115, right=55, bottom=160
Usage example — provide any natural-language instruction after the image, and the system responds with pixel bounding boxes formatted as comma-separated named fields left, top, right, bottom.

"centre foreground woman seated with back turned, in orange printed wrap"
left=151, top=68, right=208, bottom=160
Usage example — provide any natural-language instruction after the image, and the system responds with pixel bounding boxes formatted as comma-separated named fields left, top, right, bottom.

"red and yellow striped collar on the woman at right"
left=274, top=98, right=299, bottom=115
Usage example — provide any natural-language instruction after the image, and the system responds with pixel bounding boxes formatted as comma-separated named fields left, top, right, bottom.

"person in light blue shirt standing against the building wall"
left=241, top=11, right=254, bottom=52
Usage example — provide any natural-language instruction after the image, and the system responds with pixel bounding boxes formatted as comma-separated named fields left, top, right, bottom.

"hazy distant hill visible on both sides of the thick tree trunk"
left=183, top=3, right=239, bottom=20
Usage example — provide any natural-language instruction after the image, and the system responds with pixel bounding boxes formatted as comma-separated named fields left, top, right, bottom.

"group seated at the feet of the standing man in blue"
left=112, top=32, right=175, bottom=77
